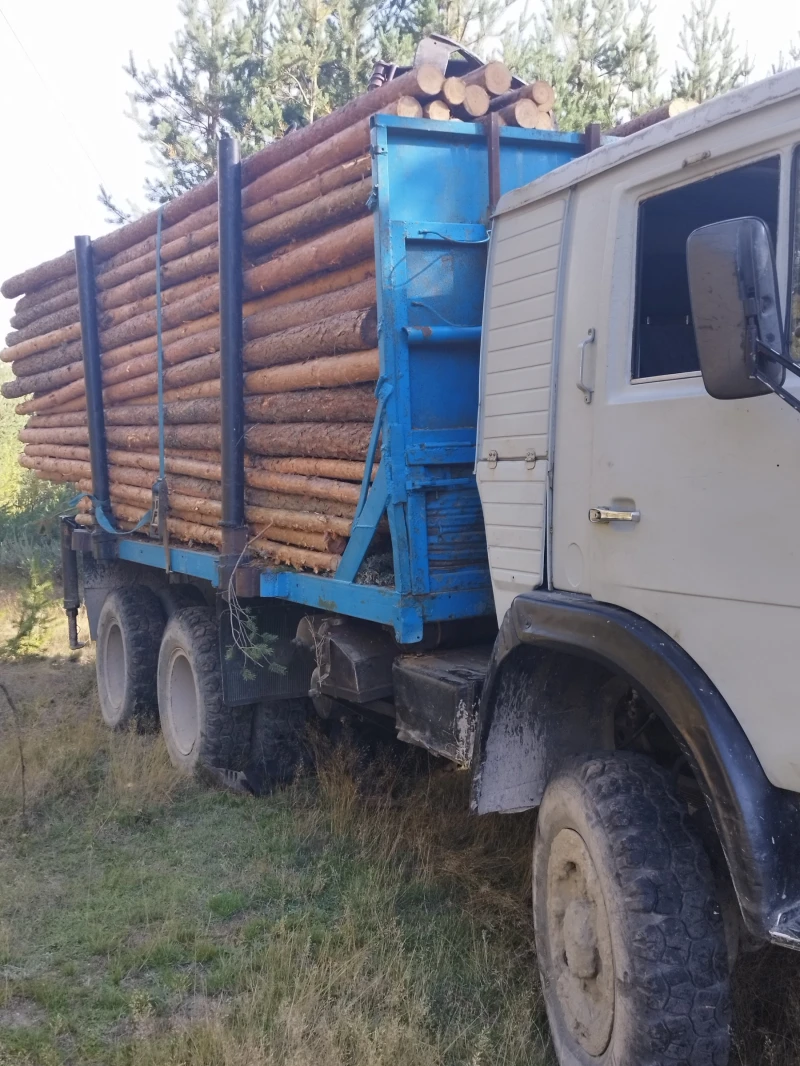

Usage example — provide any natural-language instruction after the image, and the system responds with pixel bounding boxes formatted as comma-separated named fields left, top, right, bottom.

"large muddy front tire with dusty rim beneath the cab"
left=533, top=752, right=731, bottom=1066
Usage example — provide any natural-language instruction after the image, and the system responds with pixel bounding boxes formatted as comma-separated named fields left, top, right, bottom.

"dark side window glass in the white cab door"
left=631, top=156, right=785, bottom=378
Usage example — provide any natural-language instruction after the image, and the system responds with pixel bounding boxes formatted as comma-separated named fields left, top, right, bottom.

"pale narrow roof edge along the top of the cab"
left=495, top=67, right=800, bottom=215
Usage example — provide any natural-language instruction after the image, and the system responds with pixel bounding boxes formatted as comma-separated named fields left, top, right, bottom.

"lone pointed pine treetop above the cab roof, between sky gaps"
left=672, top=0, right=753, bottom=103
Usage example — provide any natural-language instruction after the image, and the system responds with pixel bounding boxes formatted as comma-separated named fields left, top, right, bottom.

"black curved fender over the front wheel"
left=473, top=592, right=800, bottom=947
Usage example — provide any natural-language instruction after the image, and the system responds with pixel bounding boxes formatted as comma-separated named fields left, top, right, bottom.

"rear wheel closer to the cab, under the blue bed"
left=158, top=607, right=253, bottom=773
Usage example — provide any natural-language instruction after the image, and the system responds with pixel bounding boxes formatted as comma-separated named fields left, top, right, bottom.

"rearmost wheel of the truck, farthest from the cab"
left=95, top=585, right=165, bottom=730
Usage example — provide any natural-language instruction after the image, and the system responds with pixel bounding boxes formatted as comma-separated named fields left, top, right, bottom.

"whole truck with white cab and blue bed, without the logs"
left=36, top=64, right=800, bottom=1066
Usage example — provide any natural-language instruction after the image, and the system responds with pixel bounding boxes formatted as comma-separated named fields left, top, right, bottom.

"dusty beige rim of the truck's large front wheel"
left=546, top=829, right=614, bottom=1056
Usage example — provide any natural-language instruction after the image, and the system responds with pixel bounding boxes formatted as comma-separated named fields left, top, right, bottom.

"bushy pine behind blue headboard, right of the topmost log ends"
left=503, top=0, right=660, bottom=130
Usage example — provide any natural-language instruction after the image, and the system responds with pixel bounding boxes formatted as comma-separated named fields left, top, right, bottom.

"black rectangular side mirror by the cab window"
left=686, top=219, right=794, bottom=406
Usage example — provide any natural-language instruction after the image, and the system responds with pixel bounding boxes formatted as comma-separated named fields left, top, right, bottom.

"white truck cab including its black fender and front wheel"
left=475, top=70, right=800, bottom=1064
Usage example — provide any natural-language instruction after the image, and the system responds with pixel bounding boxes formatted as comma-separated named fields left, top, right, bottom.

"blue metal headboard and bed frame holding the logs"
left=117, top=115, right=586, bottom=644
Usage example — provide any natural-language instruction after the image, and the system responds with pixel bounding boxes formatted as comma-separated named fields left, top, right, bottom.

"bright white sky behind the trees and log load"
left=0, top=0, right=800, bottom=336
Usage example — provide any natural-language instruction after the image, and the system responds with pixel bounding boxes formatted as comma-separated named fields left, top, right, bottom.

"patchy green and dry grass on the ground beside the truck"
left=0, top=579, right=800, bottom=1066
